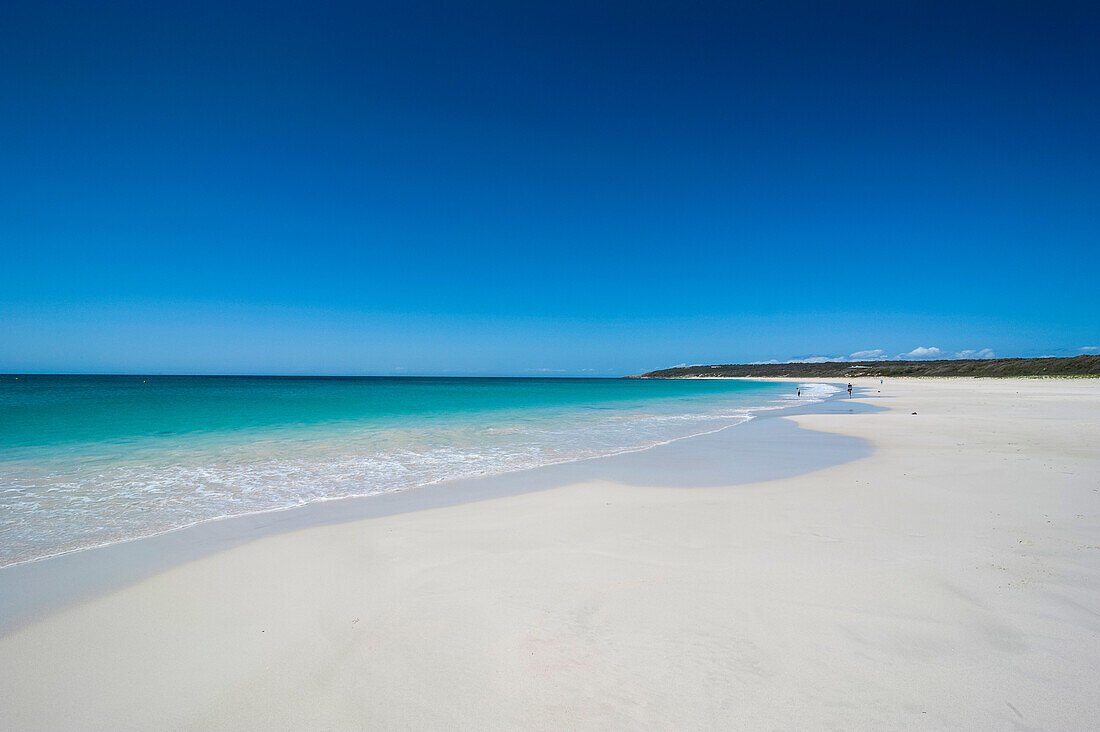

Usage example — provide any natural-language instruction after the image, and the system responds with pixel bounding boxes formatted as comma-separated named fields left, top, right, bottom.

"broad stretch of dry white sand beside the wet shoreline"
left=0, top=379, right=1100, bottom=730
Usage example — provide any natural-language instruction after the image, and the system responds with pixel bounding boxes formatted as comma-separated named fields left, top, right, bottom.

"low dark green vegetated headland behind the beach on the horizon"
left=628, top=356, right=1100, bottom=379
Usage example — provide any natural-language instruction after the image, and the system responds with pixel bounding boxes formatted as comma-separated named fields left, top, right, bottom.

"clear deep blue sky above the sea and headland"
left=0, top=0, right=1100, bottom=375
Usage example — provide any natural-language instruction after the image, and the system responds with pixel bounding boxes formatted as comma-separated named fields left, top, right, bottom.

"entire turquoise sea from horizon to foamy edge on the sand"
left=0, top=375, right=828, bottom=566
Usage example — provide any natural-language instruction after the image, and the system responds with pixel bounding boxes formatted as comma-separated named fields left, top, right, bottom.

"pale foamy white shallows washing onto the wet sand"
left=0, top=383, right=839, bottom=567
